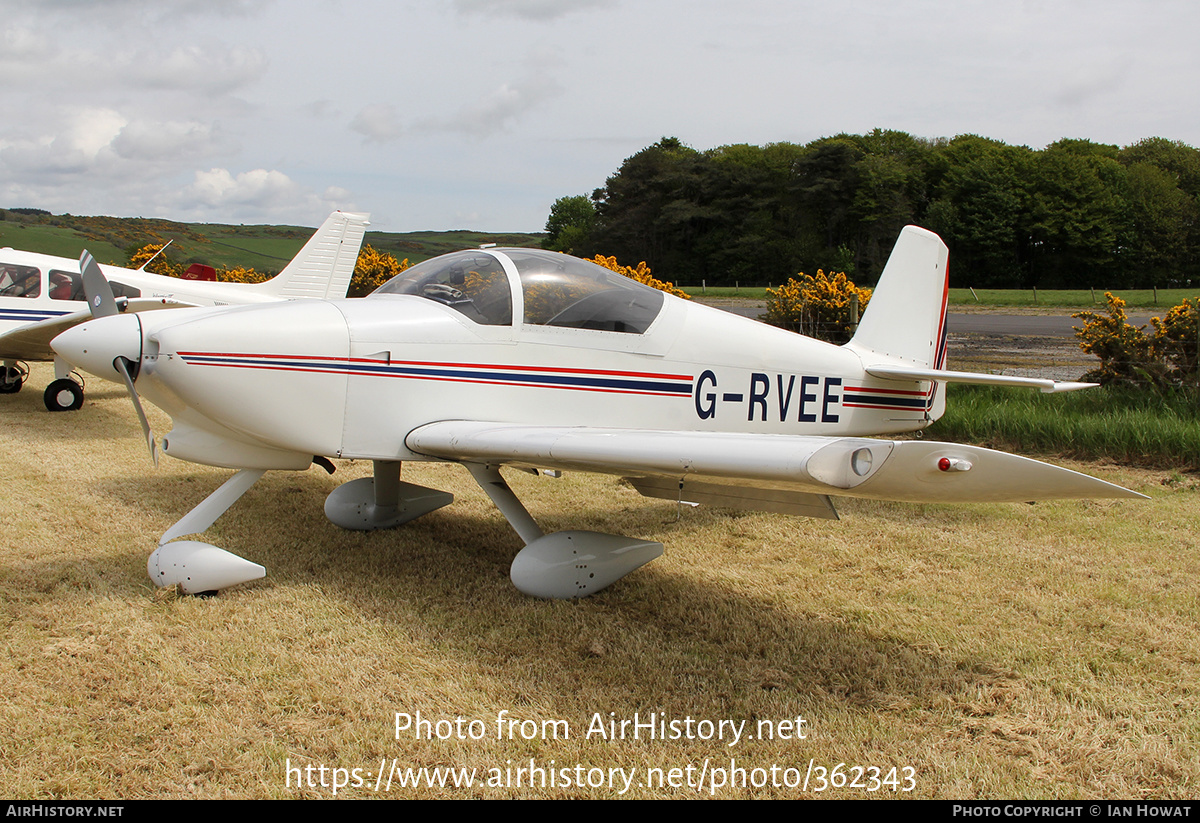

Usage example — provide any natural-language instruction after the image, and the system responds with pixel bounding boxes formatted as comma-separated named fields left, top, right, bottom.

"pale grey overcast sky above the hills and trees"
left=0, top=0, right=1200, bottom=232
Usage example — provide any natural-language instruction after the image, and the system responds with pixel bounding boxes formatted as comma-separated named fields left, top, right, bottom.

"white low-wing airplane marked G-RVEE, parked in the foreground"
left=53, top=227, right=1141, bottom=597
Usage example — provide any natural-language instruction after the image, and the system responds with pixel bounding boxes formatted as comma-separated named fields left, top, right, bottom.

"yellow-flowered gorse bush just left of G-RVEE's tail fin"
left=764, top=269, right=871, bottom=343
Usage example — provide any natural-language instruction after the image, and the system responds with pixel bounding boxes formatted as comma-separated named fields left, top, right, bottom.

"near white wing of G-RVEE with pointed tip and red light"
left=406, top=421, right=1144, bottom=517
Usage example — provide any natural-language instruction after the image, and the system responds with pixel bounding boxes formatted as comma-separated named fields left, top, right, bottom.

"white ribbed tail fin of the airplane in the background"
left=258, top=211, right=370, bottom=299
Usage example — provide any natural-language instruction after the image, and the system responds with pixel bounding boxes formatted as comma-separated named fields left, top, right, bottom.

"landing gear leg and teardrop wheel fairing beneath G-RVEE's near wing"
left=467, top=463, right=662, bottom=600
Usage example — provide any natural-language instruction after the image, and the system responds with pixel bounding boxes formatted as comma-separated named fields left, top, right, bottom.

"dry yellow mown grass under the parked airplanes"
left=0, top=367, right=1200, bottom=798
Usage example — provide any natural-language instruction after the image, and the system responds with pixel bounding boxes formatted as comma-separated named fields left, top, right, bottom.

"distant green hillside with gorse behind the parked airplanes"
left=0, top=209, right=541, bottom=271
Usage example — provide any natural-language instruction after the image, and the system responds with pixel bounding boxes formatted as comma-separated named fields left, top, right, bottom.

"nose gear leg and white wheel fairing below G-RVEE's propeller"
left=146, top=469, right=266, bottom=594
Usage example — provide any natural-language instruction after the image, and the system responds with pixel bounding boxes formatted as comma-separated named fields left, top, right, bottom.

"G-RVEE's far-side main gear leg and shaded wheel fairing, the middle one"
left=325, top=461, right=454, bottom=531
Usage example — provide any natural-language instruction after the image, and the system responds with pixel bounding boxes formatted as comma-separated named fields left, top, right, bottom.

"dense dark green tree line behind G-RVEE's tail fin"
left=544, top=130, right=1200, bottom=288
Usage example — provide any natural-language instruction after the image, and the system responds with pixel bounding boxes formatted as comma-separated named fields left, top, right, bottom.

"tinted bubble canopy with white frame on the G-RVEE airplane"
left=370, top=248, right=664, bottom=335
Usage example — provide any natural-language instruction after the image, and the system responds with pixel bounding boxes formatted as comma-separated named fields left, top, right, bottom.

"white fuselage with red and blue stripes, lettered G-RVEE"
left=105, top=295, right=930, bottom=477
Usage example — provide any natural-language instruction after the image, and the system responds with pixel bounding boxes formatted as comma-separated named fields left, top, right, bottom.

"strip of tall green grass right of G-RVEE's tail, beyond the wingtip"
left=928, top=385, right=1200, bottom=471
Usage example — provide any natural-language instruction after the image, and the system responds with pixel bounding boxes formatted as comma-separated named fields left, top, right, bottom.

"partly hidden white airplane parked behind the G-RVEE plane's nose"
left=0, top=211, right=368, bottom=412
